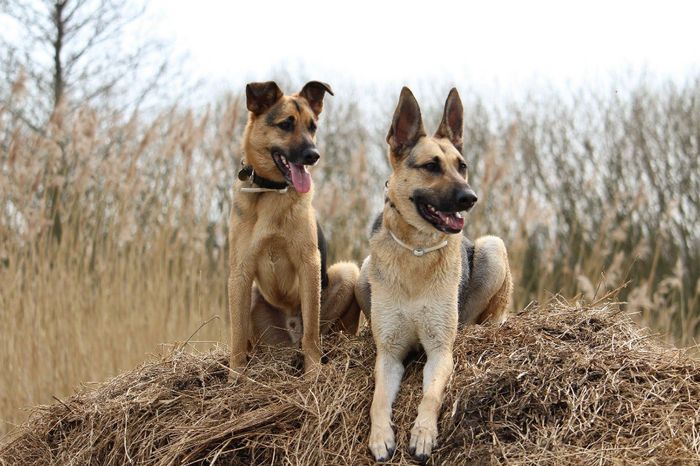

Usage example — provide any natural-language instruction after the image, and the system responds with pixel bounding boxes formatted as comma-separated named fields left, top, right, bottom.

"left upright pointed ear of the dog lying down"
left=386, top=87, right=425, bottom=156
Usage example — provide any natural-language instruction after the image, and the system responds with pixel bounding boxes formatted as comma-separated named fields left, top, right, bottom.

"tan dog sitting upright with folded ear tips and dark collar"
left=228, top=81, right=360, bottom=379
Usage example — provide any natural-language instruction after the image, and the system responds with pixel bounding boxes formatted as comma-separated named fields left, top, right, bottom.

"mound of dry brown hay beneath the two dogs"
left=0, top=302, right=700, bottom=465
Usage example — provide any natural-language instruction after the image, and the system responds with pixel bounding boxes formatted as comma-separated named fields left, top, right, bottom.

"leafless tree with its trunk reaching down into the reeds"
left=0, top=0, right=175, bottom=242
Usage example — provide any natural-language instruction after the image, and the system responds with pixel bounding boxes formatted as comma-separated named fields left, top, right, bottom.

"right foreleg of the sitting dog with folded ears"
left=299, top=249, right=321, bottom=373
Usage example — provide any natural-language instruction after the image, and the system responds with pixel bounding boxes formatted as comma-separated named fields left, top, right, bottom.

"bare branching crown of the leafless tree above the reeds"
left=0, top=0, right=168, bottom=128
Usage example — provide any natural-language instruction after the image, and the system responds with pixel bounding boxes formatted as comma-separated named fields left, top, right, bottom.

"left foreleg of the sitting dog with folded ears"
left=228, top=267, right=253, bottom=380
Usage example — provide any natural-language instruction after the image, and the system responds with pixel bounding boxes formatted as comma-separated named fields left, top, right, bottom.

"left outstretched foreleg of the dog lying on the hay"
left=369, top=348, right=404, bottom=461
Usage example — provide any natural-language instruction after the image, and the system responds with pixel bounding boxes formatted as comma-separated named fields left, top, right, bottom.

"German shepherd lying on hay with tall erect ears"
left=355, top=87, right=512, bottom=461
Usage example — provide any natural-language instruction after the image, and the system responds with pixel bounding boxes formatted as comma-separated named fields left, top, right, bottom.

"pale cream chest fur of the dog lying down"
left=369, top=233, right=462, bottom=351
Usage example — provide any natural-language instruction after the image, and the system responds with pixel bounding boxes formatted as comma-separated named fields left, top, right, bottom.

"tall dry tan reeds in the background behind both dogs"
left=0, top=72, right=700, bottom=432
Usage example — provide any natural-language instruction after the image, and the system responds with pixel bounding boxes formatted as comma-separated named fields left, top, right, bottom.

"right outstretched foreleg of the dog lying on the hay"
left=409, top=345, right=454, bottom=461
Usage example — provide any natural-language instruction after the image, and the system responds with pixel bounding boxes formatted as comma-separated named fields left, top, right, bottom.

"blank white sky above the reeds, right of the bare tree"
left=150, top=0, right=700, bottom=95
